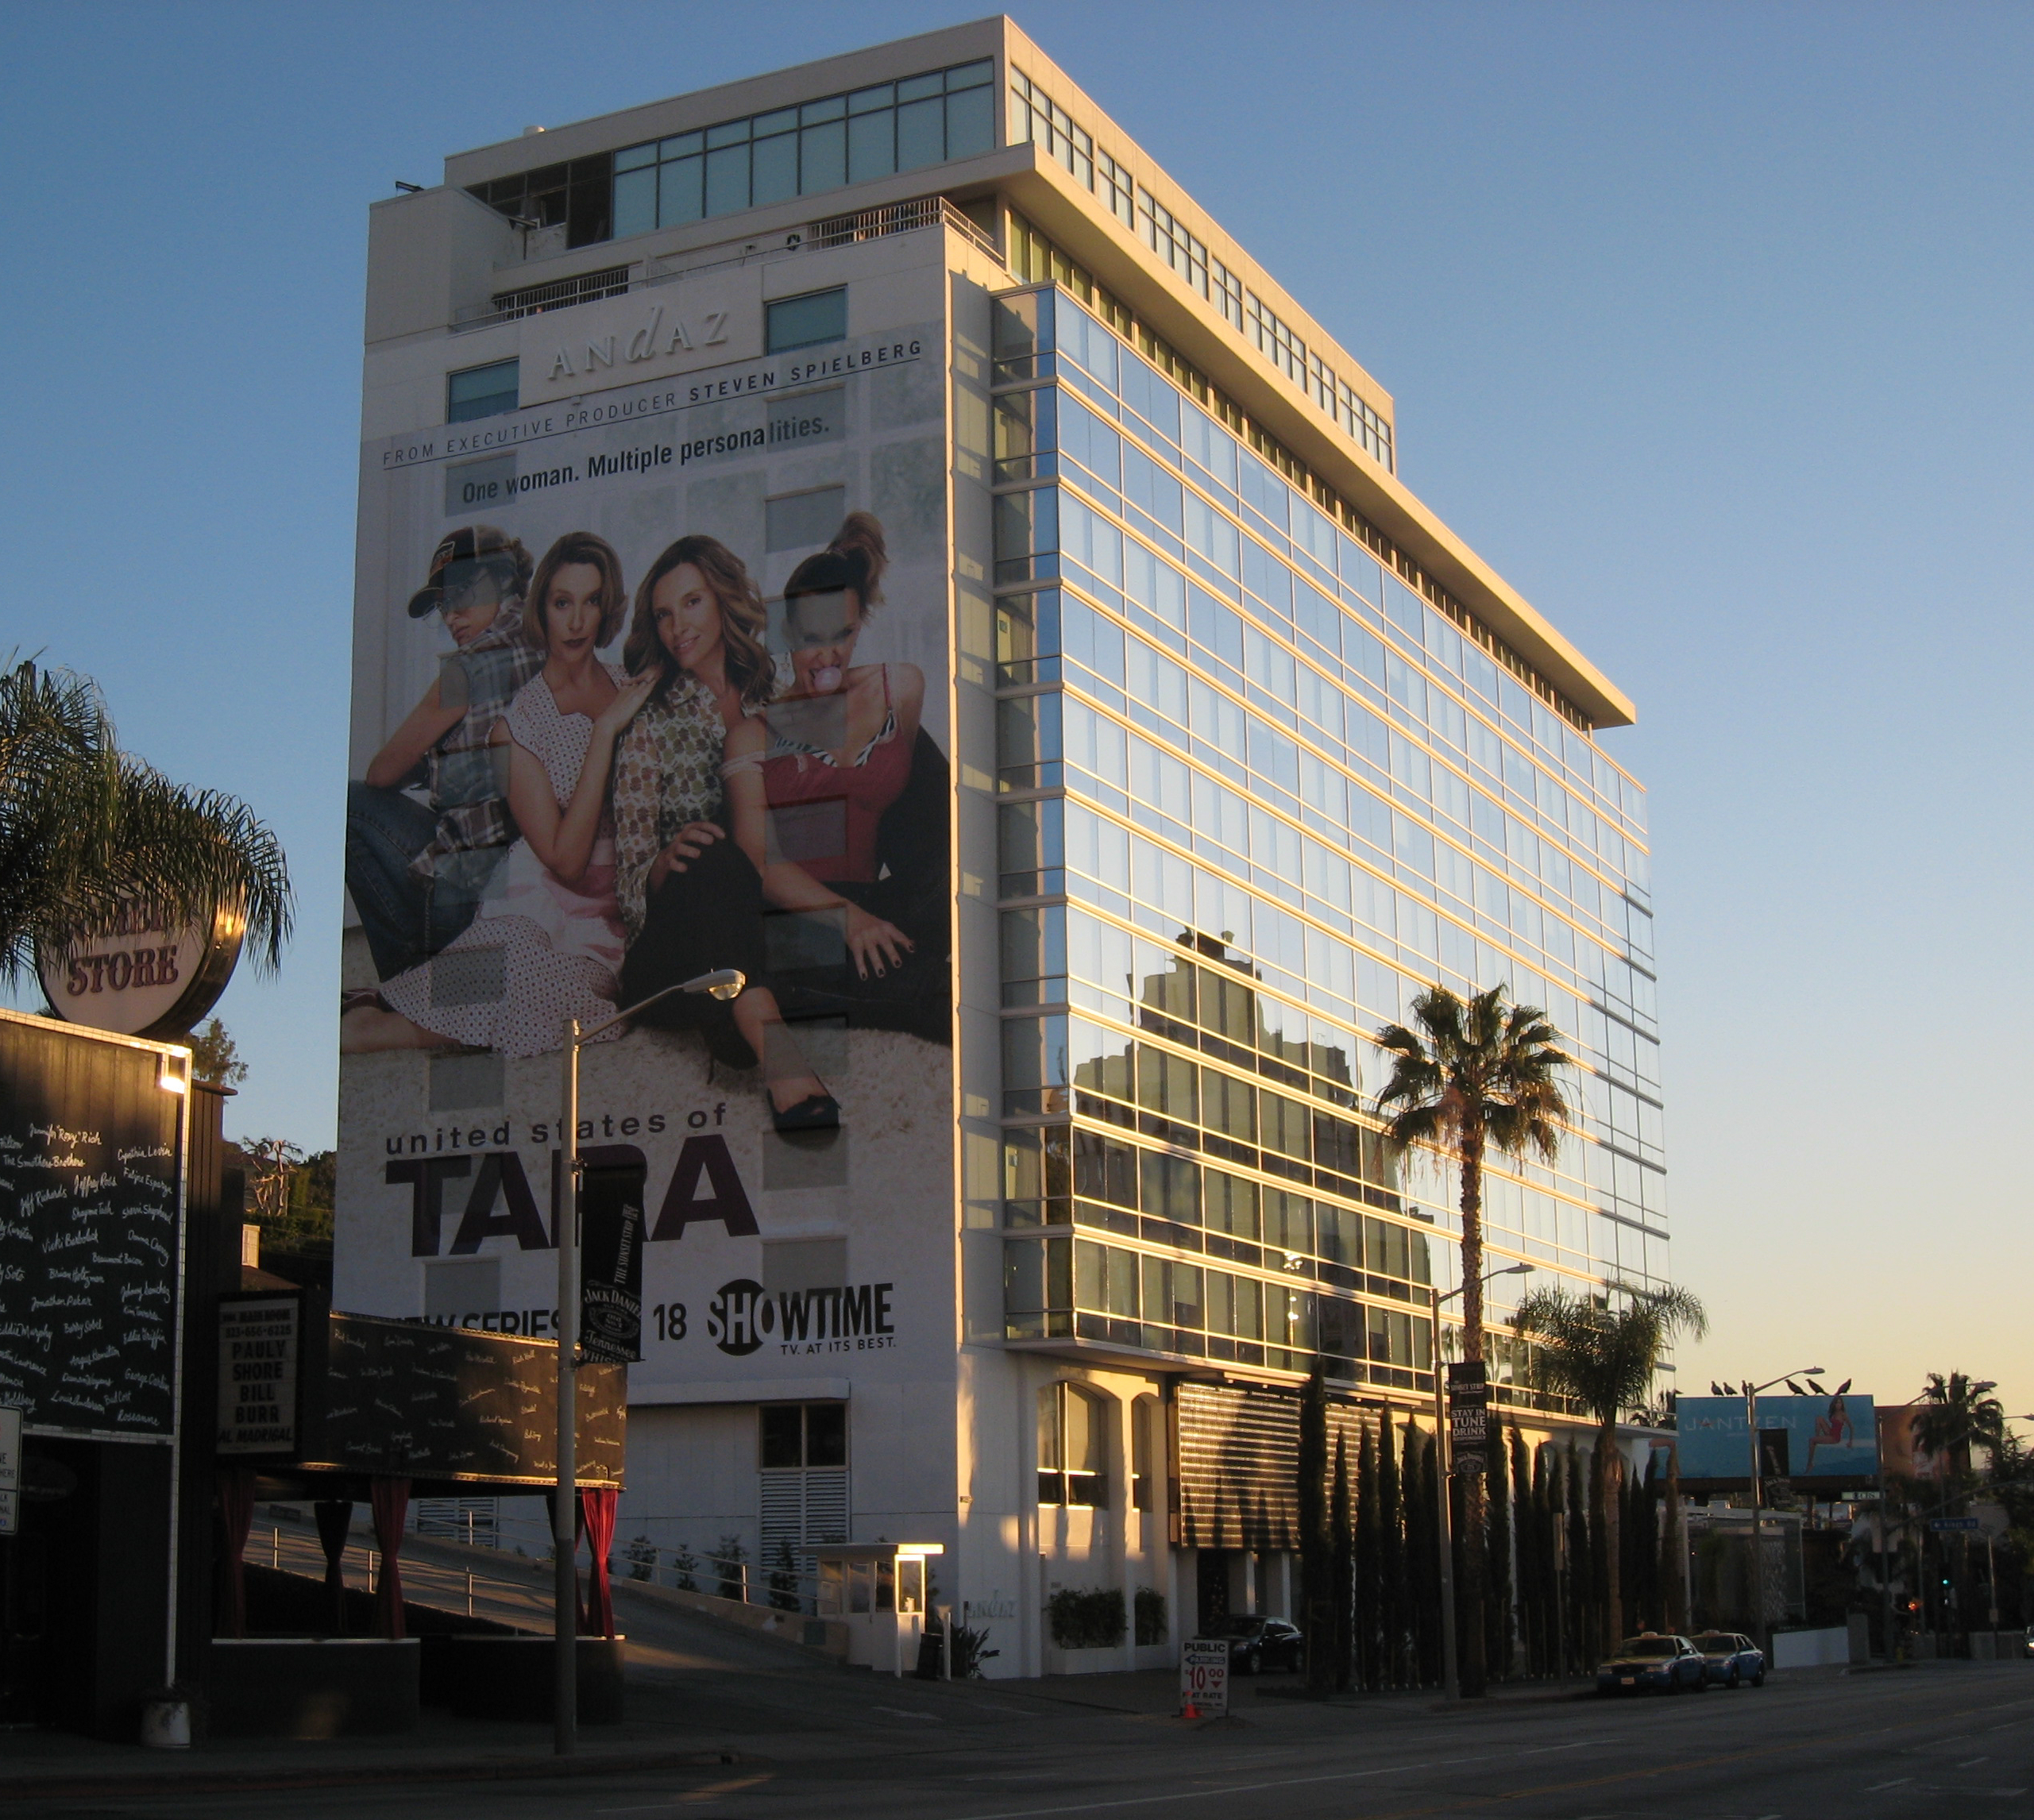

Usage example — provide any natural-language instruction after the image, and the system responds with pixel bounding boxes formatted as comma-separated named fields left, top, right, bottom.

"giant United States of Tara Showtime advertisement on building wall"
left=336, top=323, right=954, bottom=1401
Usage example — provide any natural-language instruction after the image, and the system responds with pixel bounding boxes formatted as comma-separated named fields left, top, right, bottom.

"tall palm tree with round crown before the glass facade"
left=1375, top=986, right=1573, bottom=1694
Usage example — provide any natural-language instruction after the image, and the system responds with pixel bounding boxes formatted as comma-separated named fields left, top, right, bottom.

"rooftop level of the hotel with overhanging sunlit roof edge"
left=384, top=18, right=1633, bottom=730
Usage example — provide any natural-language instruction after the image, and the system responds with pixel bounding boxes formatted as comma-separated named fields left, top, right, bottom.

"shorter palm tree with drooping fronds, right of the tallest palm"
left=1511, top=1283, right=1708, bottom=1649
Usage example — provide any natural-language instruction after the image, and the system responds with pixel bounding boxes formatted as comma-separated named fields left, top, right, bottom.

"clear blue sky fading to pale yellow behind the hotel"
left=0, top=0, right=2034, bottom=1413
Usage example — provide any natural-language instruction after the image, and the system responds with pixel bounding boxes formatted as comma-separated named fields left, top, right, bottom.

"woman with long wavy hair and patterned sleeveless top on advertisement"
left=614, top=535, right=840, bottom=1131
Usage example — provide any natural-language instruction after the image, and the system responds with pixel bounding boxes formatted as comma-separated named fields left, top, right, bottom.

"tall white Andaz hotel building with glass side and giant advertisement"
left=336, top=18, right=1668, bottom=1674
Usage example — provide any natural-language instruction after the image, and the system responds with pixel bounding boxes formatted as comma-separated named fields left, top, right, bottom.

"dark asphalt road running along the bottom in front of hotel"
left=8, top=1647, right=2034, bottom=1820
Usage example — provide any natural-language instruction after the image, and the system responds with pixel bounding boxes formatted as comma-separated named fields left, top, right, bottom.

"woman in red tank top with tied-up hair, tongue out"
left=722, top=512, right=925, bottom=980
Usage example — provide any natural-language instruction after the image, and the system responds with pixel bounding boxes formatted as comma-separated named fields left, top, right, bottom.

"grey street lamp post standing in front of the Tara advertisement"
left=551, top=968, right=748, bottom=1757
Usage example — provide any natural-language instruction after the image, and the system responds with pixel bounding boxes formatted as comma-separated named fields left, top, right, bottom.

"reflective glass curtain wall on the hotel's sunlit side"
left=994, top=287, right=1668, bottom=1401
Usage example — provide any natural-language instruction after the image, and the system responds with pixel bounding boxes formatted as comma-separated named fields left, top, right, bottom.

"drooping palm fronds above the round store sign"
left=0, top=659, right=293, bottom=980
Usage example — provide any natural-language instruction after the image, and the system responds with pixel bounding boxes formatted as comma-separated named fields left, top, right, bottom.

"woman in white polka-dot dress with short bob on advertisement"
left=340, top=530, right=653, bottom=1055
